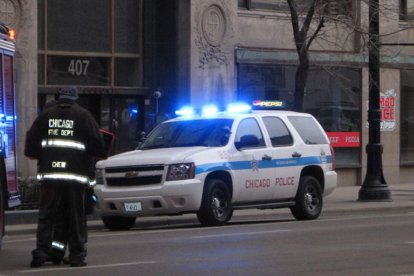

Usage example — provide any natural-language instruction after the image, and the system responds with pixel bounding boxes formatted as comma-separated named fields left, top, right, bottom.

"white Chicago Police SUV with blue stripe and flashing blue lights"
left=95, top=101, right=337, bottom=230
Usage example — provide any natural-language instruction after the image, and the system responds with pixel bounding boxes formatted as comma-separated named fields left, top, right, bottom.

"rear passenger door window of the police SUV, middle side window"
left=263, top=117, right=293, bottom=147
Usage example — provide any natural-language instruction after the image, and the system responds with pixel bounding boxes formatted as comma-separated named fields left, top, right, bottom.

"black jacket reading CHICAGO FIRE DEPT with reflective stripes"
left=25, top=100, right=107, bottom=184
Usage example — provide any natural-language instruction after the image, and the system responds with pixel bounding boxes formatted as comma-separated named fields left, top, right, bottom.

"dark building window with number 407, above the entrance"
left=38, top=0, right=143, bottom=88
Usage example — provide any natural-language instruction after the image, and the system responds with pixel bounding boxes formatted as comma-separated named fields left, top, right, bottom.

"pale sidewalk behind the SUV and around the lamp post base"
left=6, top=184, right=414, bottom=232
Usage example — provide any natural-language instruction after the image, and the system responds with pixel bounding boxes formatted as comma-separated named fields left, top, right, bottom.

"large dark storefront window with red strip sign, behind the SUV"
left=238, top=63, right=362, bottom=168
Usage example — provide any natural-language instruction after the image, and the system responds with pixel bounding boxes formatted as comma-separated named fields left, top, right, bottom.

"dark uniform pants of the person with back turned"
left=33, top=181, right=87, bottom=263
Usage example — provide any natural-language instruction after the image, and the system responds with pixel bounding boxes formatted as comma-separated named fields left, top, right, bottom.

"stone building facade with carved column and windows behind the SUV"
left=0, top=0, right=414, bottom=186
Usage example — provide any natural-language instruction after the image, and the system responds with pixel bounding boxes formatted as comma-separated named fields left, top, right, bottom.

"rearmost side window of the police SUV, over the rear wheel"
left=288, top=116, right=329, bottom=145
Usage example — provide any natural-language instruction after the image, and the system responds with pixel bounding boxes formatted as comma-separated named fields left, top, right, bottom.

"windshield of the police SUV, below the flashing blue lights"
left=140, top=119, right=233, bottom=150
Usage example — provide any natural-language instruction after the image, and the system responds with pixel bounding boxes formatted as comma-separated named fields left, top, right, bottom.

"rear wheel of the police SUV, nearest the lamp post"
left=290, top=176, right=323, bottom=220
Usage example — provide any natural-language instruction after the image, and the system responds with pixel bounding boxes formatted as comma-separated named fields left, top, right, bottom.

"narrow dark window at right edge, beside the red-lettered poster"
left=400, top=70, right=414, bottom=165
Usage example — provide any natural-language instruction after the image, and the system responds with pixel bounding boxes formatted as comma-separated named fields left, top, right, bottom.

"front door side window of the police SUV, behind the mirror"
left=234, top=118, right=265, bottom=148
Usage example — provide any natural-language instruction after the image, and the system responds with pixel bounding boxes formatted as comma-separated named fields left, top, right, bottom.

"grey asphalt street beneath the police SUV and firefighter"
left=0, top=201, right=414, bottom=276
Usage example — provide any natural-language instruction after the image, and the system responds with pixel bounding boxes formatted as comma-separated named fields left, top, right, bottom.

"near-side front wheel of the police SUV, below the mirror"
left=197, top=179, right=233, bottom=226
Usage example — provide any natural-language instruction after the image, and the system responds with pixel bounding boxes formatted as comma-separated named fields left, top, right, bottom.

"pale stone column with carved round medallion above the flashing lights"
left=189, top=0, right=237, bottom=106
